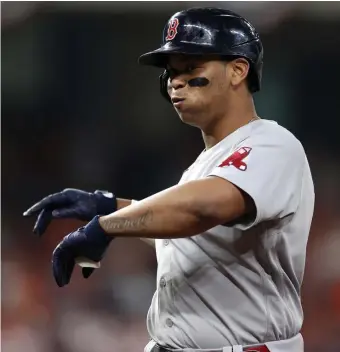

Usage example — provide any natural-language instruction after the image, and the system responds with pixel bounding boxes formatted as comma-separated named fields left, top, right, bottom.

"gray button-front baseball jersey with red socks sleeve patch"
left=147, top=120, right=314, bottom=349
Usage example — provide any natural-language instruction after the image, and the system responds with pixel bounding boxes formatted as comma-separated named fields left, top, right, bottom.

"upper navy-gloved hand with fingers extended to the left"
left=23, top=188, right=117, bottom=236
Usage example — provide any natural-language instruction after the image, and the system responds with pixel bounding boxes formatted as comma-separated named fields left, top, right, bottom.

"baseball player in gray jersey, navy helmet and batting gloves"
left=24, top=8, right=314, bottom=352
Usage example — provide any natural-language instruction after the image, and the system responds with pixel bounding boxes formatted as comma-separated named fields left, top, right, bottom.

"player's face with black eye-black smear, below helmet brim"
left=167, top=55, right=240, bottom=128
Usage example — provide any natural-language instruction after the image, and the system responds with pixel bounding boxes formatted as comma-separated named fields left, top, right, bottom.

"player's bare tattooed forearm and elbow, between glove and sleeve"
left=99, top=177, right=255, bottom=238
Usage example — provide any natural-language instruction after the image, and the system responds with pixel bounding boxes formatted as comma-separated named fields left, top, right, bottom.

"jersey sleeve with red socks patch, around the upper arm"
left=209, top=137, right=305, bottom=230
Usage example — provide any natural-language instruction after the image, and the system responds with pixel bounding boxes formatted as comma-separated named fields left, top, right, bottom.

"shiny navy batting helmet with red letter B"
left=138, top=8, right=263, bottom=100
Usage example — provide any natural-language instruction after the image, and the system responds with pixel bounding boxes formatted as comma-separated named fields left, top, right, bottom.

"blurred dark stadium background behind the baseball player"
left=1, top=1, right=340, bottom=352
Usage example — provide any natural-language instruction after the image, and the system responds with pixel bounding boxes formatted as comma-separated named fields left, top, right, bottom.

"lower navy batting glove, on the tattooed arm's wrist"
left=52, top=216, right=113, bottom=287
